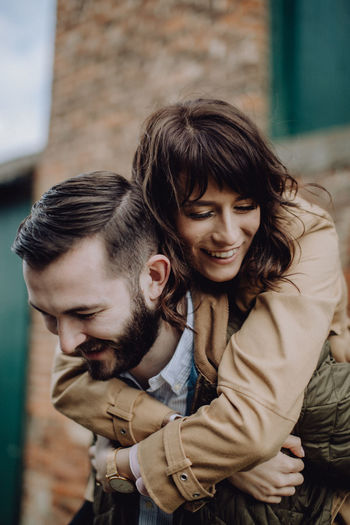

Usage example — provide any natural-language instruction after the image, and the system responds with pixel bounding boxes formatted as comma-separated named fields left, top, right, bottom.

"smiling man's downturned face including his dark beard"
left=23, top=237, right=160, bottom=379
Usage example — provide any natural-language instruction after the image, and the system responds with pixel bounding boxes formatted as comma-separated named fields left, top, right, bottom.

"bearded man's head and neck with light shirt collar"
left=15, top=172, right=200, bottom=513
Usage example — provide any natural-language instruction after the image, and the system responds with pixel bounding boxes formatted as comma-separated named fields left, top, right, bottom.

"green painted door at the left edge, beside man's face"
left=0, top=190, right=30, bottom=525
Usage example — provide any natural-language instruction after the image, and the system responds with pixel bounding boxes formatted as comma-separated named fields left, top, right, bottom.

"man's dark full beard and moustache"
left=77, top=291, right=161, bottom=381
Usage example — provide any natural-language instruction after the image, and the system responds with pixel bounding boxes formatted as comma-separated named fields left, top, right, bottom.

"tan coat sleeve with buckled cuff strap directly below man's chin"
left=51, top=348, right=174, bottom=446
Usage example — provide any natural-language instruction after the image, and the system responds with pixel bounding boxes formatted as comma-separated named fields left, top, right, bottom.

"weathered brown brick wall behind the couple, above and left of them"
left=22, top=0, right=349, bottom=525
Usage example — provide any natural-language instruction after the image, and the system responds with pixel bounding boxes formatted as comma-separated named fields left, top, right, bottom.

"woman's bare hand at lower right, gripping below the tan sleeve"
left=229, top=435, right=304, bottom=503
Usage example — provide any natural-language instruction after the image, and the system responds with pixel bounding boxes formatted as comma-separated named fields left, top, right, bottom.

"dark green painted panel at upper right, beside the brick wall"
left=270, top=0, right=350, bottom=137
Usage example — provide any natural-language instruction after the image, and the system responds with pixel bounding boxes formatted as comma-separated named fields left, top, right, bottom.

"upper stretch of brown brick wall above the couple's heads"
left=36, top=0, right=268, bottom=194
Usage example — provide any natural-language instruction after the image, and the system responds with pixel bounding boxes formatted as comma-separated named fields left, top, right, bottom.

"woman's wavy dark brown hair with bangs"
left=133, top=99, right=298, bottom=320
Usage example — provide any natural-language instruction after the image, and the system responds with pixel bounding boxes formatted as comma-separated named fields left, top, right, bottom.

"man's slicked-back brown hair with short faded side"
left=12, top=171, right=158, bottom=282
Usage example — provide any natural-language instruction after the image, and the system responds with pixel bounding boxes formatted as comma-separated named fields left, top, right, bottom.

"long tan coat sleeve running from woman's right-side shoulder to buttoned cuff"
left=138, top=202, right=344, bottom=512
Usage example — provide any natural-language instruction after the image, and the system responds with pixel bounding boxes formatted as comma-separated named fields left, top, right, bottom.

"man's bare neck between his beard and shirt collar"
left=129, top=320, right=182, bottom=388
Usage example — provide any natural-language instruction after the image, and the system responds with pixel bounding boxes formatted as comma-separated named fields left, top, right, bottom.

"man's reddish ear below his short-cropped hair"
left=140, top=253, right=171, bottom=303
